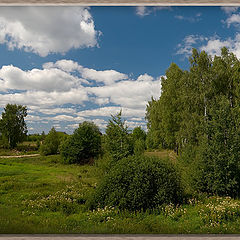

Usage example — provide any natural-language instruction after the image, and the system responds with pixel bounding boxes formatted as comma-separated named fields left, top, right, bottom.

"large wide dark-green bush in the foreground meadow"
left=88, top=156, right=183, bottom=211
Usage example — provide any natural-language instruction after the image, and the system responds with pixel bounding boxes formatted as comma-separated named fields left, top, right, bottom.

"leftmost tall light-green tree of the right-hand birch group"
left=146, top=63, right=184, bottom=150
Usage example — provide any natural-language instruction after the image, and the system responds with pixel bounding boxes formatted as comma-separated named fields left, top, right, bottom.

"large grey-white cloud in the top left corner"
left=0, top=6, right=100, bottom=57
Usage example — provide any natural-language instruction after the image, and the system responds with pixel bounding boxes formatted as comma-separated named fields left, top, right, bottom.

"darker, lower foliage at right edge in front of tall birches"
left=195, top=97, right=240, bottom=197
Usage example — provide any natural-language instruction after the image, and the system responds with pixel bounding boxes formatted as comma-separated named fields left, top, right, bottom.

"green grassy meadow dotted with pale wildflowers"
left=0, top=153, right=240, bottom=233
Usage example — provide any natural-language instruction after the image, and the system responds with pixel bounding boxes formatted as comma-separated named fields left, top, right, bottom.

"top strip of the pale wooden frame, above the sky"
left=0, top=0, right=240, bottom=6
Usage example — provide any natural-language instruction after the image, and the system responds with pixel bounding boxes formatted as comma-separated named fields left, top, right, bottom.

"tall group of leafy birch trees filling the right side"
left=146, top=48, right=240, bottom=196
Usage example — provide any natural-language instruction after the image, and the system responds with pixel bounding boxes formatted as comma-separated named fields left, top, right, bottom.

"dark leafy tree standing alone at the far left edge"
left=0, top=104, right=27, bottom=148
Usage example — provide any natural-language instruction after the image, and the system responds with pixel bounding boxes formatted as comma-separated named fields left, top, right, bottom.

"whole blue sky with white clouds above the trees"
left=0, top=6, right=240, bottom=133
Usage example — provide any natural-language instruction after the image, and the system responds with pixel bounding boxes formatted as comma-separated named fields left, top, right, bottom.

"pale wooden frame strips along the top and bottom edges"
left=0, top=0, right=240, bottom=240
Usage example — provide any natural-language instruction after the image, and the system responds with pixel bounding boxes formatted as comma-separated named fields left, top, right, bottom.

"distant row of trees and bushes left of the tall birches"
left=0, top=104, right=146, bottom=164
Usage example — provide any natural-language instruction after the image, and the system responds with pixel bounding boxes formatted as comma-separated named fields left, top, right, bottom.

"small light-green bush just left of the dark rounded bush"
left=40, top=127, right=60, bottom=156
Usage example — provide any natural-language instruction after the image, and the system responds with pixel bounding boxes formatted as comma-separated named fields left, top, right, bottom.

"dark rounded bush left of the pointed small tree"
left=60, top=121, right=101, bottom=164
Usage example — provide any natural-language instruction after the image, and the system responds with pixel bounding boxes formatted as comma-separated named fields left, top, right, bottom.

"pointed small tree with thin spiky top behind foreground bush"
left=106, top=111, right=133, bottom=161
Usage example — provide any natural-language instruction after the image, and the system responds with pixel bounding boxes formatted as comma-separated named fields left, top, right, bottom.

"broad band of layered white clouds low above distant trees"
left=0, top=59, right=161, bottom=132
